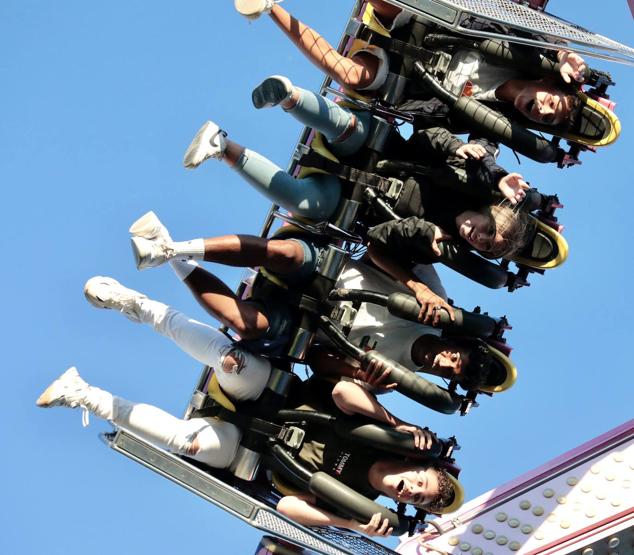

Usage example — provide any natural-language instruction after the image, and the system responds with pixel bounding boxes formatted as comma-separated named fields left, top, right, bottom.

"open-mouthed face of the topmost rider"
left=513, top=81, right=569, bottom=125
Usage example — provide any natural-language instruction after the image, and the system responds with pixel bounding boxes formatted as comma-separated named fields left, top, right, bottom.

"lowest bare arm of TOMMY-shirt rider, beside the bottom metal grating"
left=277, top=494, right=392, bottom=536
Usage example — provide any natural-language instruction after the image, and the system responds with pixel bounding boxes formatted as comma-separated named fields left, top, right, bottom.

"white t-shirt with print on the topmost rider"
left=443, top=50, right=521, bottom=101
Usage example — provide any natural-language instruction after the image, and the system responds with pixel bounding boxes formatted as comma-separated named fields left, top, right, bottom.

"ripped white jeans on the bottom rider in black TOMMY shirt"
left=96, top=299, right=271, bottom=468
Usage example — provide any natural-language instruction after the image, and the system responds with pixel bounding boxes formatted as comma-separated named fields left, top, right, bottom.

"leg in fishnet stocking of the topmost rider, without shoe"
left=270, top=4, right=379, bottom=89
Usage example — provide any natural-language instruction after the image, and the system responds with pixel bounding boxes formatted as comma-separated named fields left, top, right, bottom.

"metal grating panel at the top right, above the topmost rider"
left=394, top=0, right=634, bottom=65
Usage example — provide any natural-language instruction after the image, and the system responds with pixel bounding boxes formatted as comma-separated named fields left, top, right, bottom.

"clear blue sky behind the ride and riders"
left=0, top=0, right=634, bottom=555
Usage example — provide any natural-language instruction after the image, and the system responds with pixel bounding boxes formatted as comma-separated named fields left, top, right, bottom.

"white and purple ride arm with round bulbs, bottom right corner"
left=397, top=420, right=634, bottom=555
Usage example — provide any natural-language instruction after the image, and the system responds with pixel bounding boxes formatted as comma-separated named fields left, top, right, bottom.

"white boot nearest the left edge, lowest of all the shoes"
left=35, top=366, right=113, bottom=426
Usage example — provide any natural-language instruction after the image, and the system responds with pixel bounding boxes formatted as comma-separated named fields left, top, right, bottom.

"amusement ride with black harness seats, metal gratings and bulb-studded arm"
left=76, top=0, right=634, bottom=555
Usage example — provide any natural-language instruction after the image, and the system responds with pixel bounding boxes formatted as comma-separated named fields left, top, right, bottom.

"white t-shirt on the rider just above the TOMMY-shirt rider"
left=336, top=260, right=446, bottom=370
